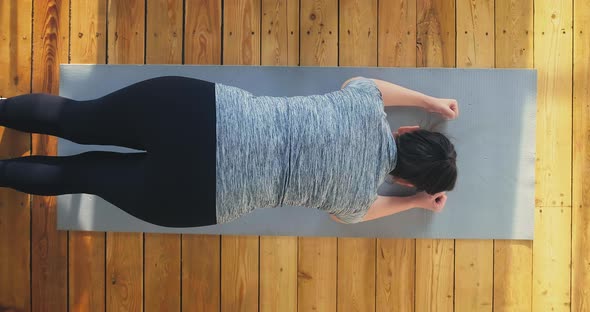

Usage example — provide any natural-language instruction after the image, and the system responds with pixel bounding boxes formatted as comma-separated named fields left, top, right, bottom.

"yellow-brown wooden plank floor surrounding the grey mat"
left=0, top=0, right=590, bottom=312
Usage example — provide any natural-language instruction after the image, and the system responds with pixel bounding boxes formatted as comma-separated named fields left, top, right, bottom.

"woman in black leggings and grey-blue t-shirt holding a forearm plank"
left=0, top=77, right=458, bottom=227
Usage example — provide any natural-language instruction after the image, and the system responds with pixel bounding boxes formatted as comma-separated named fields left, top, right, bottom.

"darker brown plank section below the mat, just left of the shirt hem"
left=182, top=235, right=221, bottom=312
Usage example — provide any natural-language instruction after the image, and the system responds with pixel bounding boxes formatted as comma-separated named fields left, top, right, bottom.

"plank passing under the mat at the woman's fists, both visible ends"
left=415, top=0, right=455, bottom=311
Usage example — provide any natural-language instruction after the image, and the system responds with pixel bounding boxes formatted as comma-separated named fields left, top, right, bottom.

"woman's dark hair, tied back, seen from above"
left=390, top=130, right=457, bottom=195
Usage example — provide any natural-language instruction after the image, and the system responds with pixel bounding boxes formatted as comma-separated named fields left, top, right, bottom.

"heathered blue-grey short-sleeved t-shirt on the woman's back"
left=215, top=78, right=396, bottom=223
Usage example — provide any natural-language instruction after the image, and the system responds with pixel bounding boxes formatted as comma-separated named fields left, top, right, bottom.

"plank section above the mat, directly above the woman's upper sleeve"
left=339, top=0, right=377, bottom=66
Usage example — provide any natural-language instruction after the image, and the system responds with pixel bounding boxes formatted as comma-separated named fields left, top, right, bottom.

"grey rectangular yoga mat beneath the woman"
left=58, top=65, right=537, bottom=239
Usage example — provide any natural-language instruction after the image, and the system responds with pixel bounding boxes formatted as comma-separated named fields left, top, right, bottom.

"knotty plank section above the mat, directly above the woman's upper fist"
left=416, top=0, right=455, bottom=67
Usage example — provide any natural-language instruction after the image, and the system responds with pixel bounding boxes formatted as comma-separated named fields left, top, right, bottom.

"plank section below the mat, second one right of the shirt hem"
left=260, top=236, right=297, bottom=312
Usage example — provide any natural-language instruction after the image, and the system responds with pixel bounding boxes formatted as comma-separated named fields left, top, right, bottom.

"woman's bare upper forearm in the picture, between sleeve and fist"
left=373, top=79, right=434, bottom=109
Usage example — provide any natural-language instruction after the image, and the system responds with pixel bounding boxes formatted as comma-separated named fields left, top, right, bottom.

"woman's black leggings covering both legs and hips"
left=0, top=77, right=216, bottom=227
